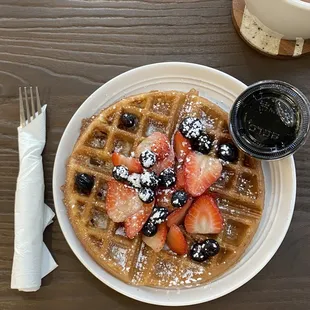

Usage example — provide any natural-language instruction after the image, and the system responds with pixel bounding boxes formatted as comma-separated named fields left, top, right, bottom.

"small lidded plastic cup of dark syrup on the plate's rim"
left=229, top=80, right=310, bottom=160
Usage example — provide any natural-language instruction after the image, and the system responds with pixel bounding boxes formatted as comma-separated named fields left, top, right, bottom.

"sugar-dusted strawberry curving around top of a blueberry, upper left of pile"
left=135, top=132, right=170, bottom=160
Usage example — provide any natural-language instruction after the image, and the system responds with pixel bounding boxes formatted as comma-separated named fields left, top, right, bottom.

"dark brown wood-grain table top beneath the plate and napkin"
left=0, top=0, right=310, bottom=310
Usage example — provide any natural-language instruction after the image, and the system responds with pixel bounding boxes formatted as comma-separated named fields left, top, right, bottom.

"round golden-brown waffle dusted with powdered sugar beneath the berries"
left=63, top=90, right=264, bottom=288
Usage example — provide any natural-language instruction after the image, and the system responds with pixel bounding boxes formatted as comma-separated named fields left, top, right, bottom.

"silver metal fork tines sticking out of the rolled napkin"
left=19, top=86, right=42, bottom=127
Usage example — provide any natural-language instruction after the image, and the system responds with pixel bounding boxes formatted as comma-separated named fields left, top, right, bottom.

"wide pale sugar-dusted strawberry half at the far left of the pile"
left=106, top=180, right=143, bottom=223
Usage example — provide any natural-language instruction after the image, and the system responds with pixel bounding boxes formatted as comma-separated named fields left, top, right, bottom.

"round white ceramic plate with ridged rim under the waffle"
left=53, top=62, right=296, bottom=306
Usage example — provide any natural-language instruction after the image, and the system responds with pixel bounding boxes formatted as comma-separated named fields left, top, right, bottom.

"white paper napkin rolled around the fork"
left=11, top=105, right=57, bottom=292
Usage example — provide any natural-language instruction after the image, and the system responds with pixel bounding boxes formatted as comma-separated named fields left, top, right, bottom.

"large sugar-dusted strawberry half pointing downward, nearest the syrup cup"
left=184, top=152, right=222, bottom=197
